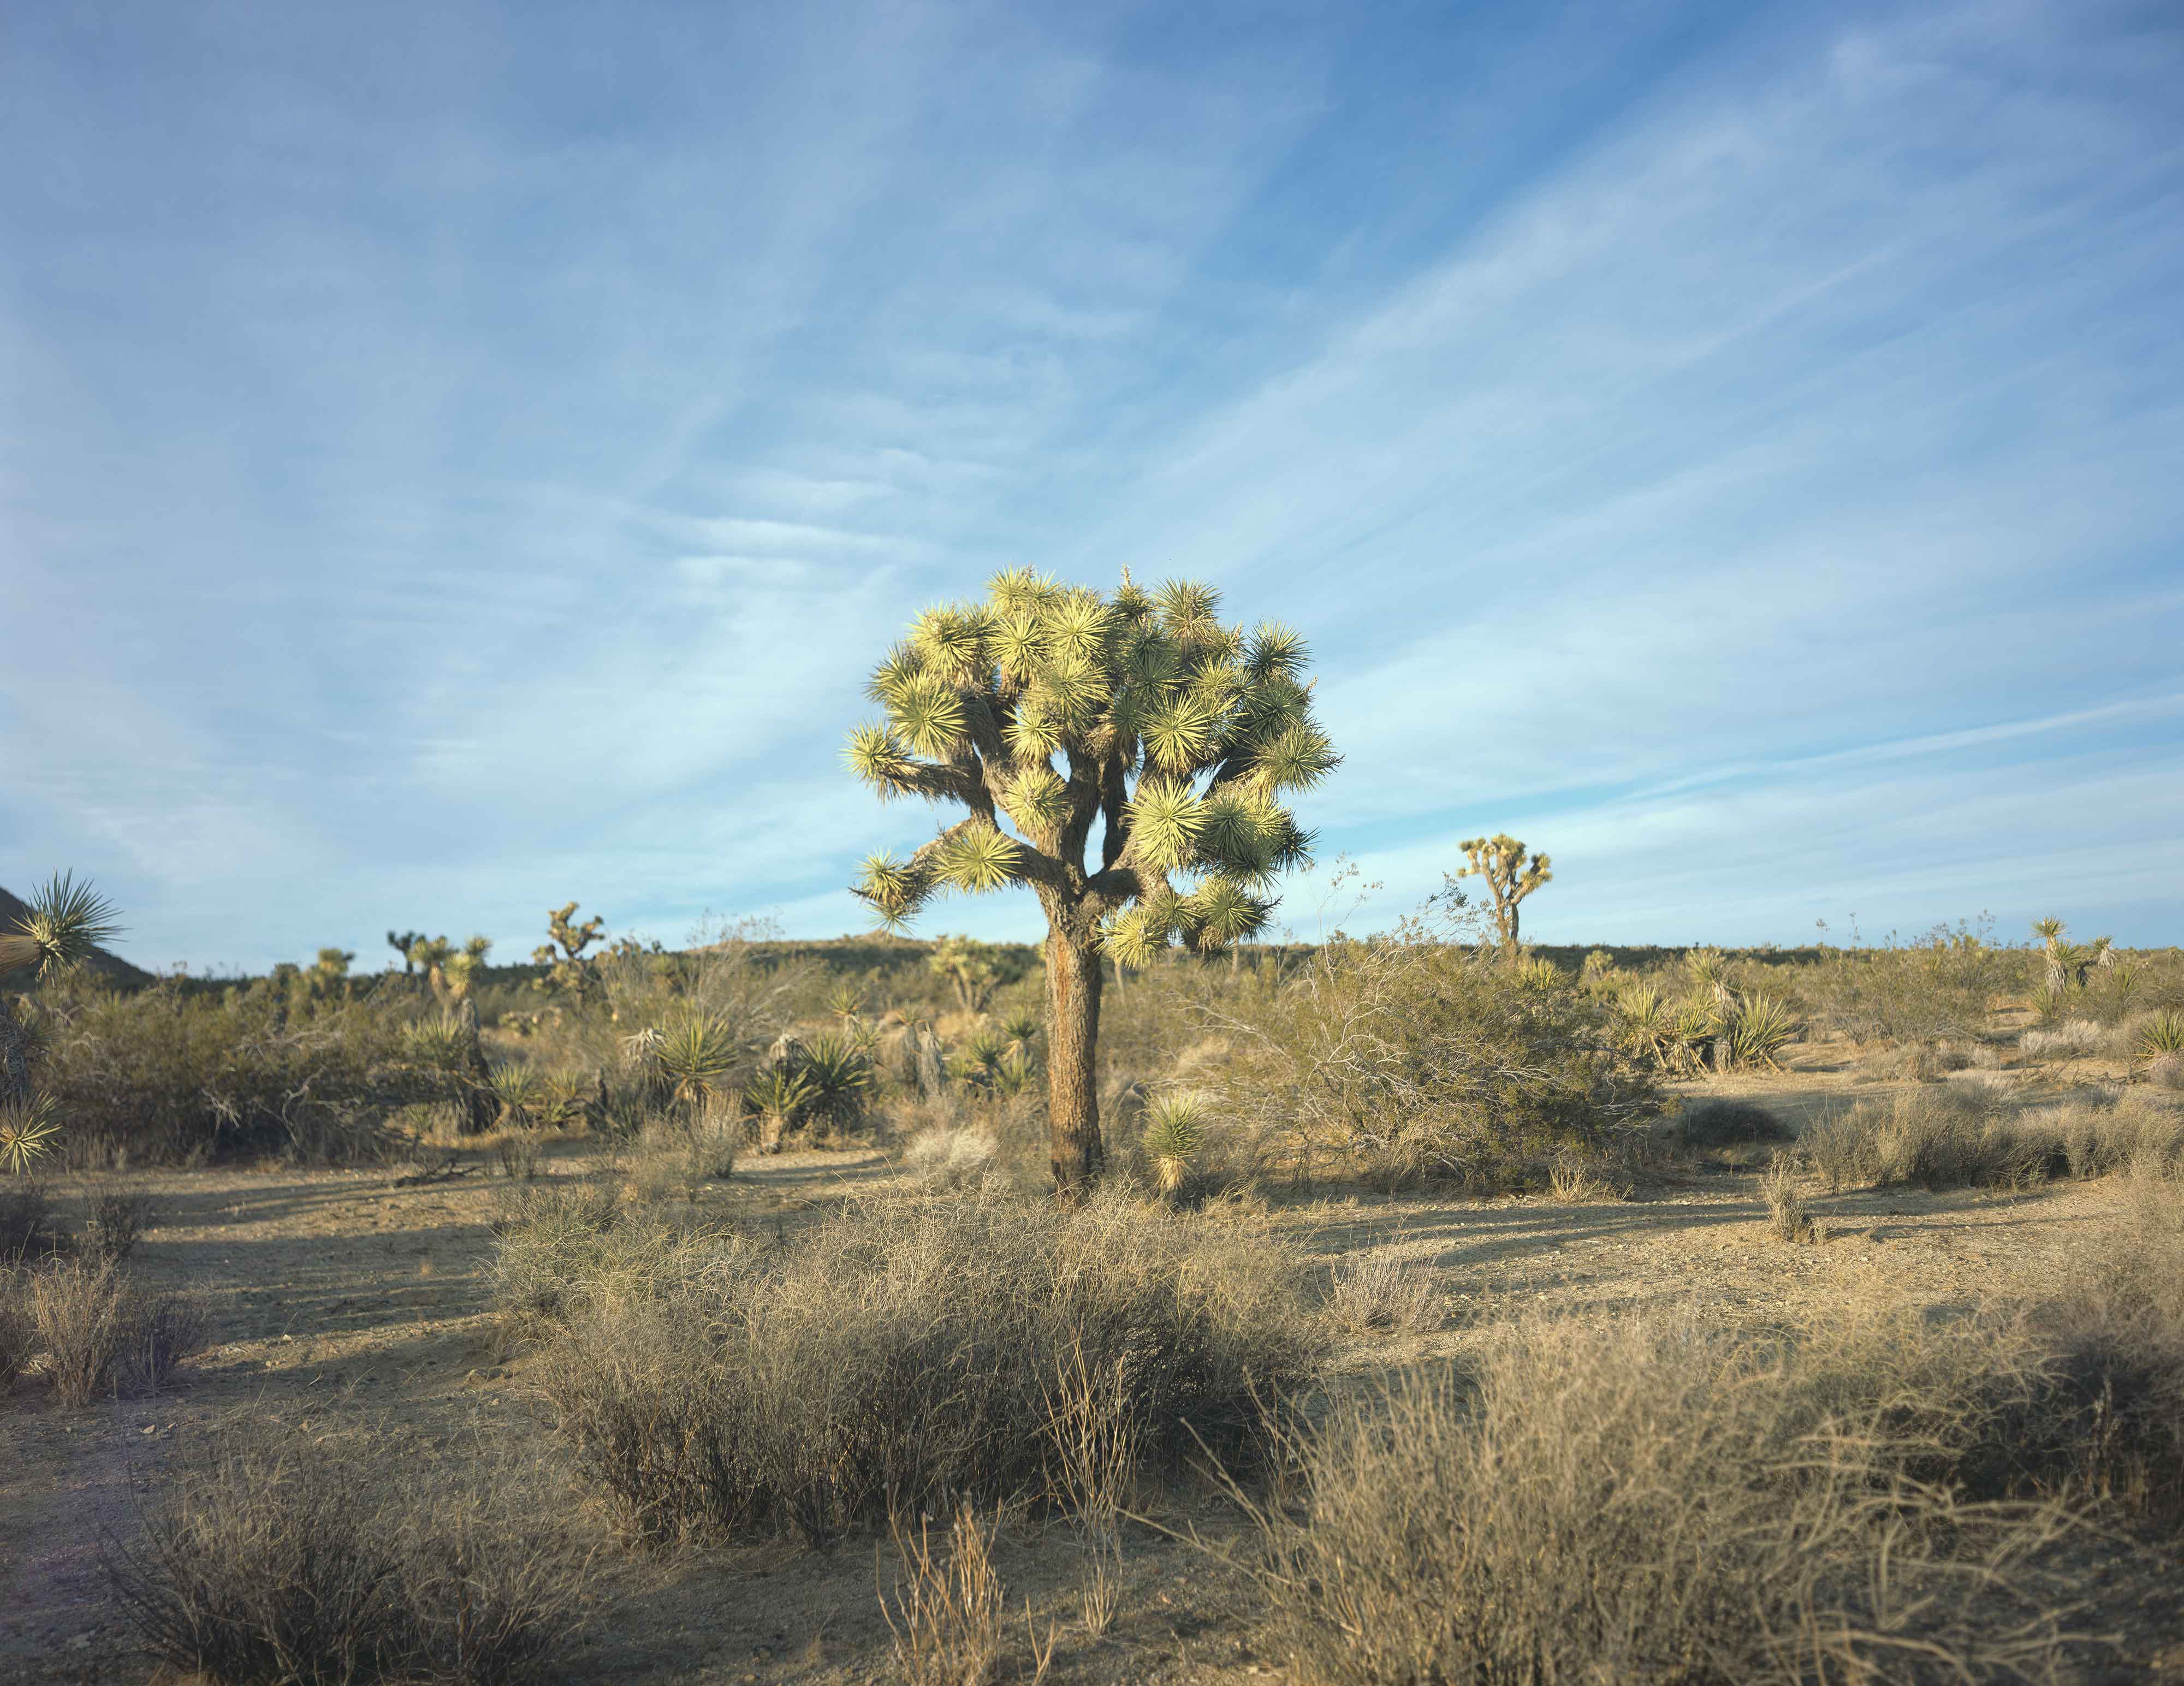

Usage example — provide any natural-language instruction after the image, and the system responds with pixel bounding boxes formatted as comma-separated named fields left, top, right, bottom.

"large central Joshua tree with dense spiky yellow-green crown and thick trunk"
left=850, top=570, right=1341, bottom=1197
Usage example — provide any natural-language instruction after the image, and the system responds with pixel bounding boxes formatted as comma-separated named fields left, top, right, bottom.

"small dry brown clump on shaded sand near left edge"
left=26, top=1260, right=207, bottom=1406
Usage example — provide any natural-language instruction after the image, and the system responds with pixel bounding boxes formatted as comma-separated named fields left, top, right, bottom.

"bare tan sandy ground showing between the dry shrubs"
left=0, top=1064, right=2184, bottom=1686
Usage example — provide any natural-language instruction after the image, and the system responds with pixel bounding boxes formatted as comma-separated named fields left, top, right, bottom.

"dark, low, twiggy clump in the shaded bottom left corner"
left=105, top=1433, right=585, bottom=1686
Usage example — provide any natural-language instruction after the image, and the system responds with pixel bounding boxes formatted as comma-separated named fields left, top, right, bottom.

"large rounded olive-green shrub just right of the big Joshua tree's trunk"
left=1197, top=904, right=1660, bottom=1192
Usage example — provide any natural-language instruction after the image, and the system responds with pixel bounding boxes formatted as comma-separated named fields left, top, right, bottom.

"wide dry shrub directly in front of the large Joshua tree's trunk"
left=539, top=1192, right=1317, bottom=1540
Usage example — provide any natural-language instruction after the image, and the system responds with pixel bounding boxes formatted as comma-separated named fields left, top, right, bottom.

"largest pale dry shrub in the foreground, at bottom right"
left=1256, top=1315, right=2097, bottom=1686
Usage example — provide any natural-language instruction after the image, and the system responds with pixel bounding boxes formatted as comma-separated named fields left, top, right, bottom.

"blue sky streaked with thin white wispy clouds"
left=0, top=0, right=2184, bottom=967
